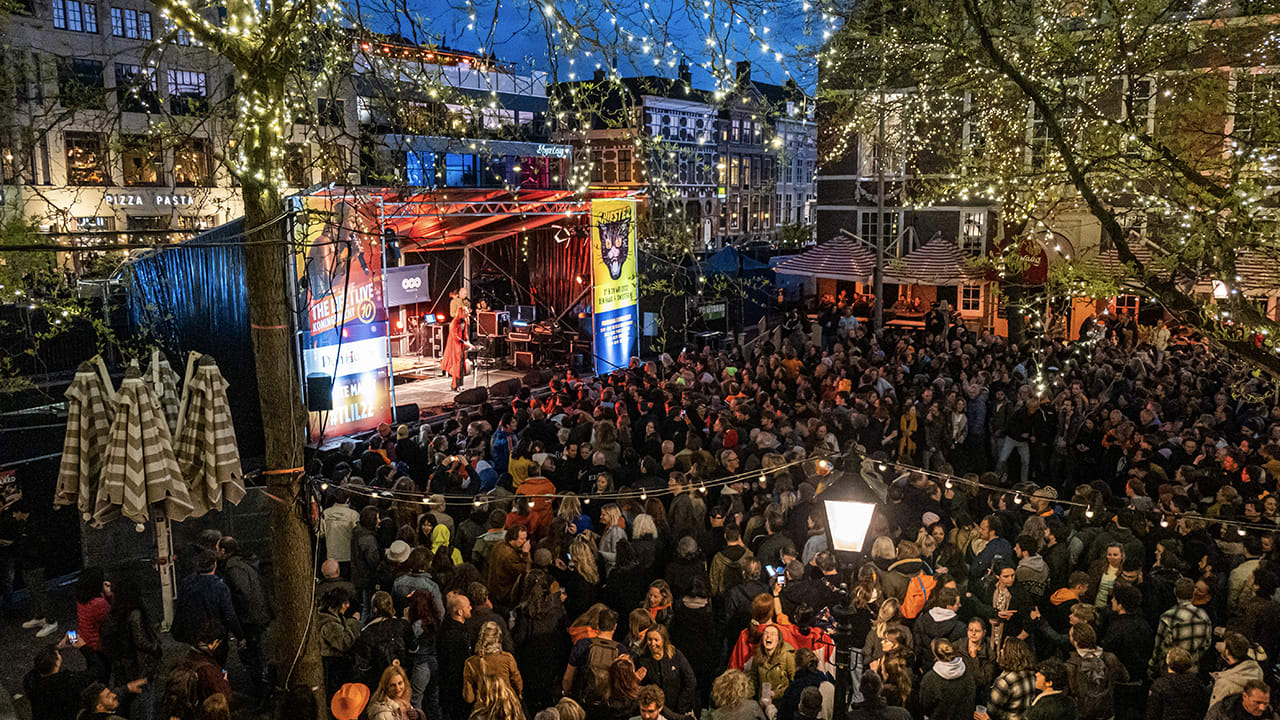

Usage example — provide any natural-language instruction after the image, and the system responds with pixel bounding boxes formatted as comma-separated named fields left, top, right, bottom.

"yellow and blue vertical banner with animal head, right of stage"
left=591, top=200, right=640, bottom=375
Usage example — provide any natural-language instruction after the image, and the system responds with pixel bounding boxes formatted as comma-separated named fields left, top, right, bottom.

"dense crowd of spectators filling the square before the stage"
left=7, top=305, right=1280, bottom=720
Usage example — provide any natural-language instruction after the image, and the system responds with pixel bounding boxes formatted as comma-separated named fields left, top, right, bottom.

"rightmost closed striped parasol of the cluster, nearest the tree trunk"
left=174, top=354, right=244, bottom=518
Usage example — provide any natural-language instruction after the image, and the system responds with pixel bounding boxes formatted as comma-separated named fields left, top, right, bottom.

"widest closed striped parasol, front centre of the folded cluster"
left=93, top=368, right=192, bottom=527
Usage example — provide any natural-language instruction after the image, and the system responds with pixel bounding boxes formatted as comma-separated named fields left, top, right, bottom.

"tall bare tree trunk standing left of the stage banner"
left=243, top=79, right=324, bottom=694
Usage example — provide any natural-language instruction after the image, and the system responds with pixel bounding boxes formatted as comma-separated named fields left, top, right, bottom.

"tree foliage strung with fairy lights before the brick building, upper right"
left=820, top=0, right=1280, bottom=377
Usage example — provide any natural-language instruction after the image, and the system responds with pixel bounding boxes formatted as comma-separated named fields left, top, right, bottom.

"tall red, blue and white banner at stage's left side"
left=294, top=197, right=392, bottom=442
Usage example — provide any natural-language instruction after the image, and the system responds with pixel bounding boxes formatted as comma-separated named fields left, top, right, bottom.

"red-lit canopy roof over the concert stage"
left=311, top=187, right=640, bottom=251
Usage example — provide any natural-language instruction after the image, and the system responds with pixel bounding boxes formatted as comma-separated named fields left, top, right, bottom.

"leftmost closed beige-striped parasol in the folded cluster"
left=54, top=356, right=115, bottom=519
